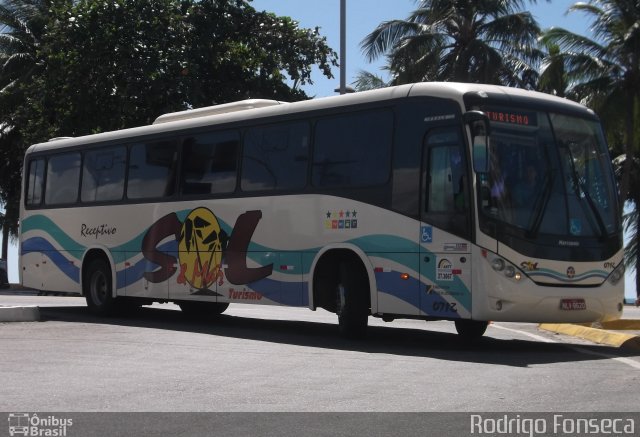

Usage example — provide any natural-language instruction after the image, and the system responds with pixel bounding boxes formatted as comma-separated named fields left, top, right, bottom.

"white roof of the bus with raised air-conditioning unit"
left=28, top=82, right=585, bottom=153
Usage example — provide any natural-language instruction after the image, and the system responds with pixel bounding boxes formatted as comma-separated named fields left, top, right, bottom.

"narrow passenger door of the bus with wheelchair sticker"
left=420, top=125, right=471, bottom=319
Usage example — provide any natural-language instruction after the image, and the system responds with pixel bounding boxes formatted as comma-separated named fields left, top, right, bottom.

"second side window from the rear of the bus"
left=44, top=153, right=81, bottom=205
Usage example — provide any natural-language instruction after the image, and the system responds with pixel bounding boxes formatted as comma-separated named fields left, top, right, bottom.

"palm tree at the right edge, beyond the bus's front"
left=541, top=0, right=640, bottom=300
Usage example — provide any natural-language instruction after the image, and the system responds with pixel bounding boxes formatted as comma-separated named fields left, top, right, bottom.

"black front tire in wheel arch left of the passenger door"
left=336, top=262, right=369, bottom=339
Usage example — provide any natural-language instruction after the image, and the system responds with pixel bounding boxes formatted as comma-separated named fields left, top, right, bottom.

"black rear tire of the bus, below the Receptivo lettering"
left=84, top=258, right=116, bottom=316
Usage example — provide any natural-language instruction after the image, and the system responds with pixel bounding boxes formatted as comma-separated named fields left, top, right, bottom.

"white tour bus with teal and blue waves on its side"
left=20, top=83, right=624, bottom=337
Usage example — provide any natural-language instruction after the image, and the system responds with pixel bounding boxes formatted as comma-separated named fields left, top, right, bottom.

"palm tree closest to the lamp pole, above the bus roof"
left=361, top=0, right=540, bottom=87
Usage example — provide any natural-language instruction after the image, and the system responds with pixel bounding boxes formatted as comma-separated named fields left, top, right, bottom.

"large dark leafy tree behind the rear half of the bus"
left=19, top=0, right=336, bottom=136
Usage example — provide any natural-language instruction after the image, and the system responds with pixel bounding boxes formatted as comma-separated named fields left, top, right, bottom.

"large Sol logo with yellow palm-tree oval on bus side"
left=142, top=208, right=273, bottom=290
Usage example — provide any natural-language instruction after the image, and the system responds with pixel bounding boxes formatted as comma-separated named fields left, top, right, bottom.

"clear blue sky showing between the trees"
left=0, top=0, right=635, bottom=300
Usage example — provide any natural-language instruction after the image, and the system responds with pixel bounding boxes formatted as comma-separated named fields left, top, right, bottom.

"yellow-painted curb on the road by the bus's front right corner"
left=539, top=320, right=640, bottom=351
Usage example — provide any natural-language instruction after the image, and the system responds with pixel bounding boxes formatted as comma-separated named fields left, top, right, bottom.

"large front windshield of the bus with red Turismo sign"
left=479, top=108, right=619, bottom=238
